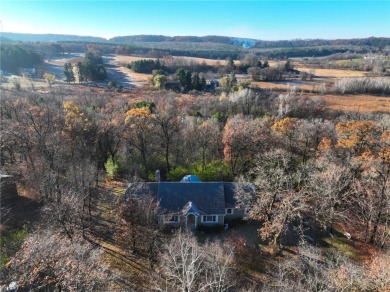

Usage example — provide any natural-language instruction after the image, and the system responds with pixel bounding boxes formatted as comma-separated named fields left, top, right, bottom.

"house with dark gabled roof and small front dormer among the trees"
left=126, top=175, right=254, bottom=228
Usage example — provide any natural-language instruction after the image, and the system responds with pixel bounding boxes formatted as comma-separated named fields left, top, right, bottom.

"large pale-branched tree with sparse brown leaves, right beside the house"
left=242, top=149, right=308, bottom=246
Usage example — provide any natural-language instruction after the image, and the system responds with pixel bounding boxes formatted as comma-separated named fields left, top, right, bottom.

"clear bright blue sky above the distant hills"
left=0, top=0, right=390, bottom=40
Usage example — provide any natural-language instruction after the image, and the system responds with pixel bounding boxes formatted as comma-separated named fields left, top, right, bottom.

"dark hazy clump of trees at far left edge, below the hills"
left=0, top=45, right=43, bottom=73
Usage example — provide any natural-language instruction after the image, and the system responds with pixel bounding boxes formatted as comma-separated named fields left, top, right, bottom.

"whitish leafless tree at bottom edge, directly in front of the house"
left=156, top=231, right=234, bottom=292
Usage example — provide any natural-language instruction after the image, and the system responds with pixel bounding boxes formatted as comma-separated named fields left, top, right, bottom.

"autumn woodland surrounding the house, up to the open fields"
left=1, top=80, right=390, bottom=291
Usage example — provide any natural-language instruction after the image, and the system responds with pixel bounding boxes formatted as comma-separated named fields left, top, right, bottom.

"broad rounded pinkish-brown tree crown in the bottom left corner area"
left=7, top=231, right=111, bottom=291
